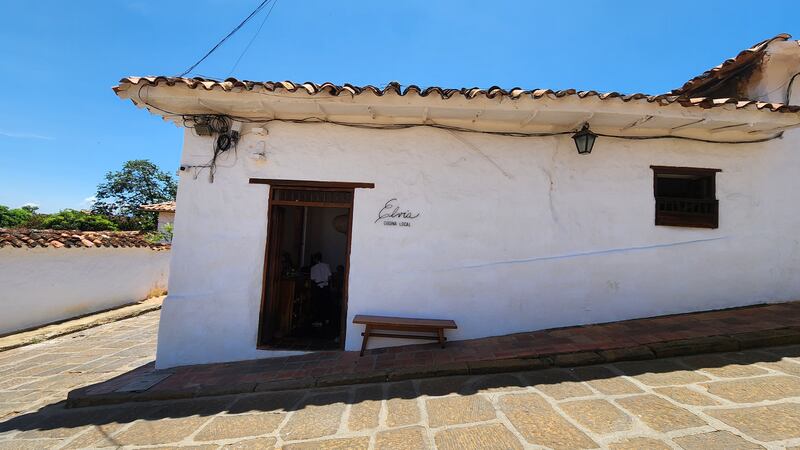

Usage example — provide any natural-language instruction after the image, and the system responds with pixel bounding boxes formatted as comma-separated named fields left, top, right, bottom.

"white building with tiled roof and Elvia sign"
left=115, top=35, right=800, bottom=367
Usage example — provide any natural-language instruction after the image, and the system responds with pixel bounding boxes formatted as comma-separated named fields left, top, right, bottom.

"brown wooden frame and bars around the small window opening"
left=650, top=166, right=722, bottom=229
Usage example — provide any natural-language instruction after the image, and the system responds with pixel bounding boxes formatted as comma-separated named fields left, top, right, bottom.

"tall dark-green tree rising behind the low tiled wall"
left=92, top=159, right=178, bottom=231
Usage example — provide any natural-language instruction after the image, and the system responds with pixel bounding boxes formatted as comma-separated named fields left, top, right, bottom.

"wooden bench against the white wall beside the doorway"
left=353, top=314, right=458, bottom=356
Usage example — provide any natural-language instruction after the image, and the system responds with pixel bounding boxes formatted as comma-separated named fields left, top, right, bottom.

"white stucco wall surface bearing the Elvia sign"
left=157, top=117, right=800, bottom=367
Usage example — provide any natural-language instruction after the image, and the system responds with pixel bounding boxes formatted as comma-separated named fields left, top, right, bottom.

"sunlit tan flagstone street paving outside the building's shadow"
left=0, top=313, right=800, bottom=450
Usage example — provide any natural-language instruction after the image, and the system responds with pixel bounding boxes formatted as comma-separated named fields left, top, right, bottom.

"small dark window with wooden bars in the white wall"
left=651, top=166, right=720, bottom=228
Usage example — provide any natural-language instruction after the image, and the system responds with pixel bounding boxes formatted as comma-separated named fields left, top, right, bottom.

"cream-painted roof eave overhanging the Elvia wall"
left=117, top=80, right=800, bottom=139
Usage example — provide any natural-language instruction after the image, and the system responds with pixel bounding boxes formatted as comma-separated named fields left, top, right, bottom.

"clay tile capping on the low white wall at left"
left=0, top=228, right=170, bottom=250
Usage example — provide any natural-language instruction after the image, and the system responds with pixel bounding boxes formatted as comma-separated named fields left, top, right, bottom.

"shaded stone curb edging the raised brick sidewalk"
left=66, top=327, right=800, bottom=408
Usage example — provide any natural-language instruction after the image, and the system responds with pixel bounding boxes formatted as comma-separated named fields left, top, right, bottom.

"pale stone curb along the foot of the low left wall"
left=0, top=296, right=164, bottom=352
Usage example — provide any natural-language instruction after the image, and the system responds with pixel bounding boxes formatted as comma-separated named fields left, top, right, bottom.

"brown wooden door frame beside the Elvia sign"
left=250, top=178, right=375, bottom=350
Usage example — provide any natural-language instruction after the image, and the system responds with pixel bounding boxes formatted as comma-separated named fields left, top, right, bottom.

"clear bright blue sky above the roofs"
left=0, top=0, right=800, bottom=212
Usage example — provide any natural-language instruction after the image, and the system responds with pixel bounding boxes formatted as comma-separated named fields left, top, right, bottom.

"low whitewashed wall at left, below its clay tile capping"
left=0, top=247, right=170, bottom=335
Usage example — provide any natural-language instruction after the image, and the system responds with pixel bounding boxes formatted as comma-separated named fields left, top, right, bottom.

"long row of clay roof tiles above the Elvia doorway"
left=113, top=77, right=800, bottom=113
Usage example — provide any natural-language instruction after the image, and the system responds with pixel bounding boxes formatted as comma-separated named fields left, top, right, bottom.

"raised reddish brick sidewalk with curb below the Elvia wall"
left=67, top=301, right=800, bottom=407
